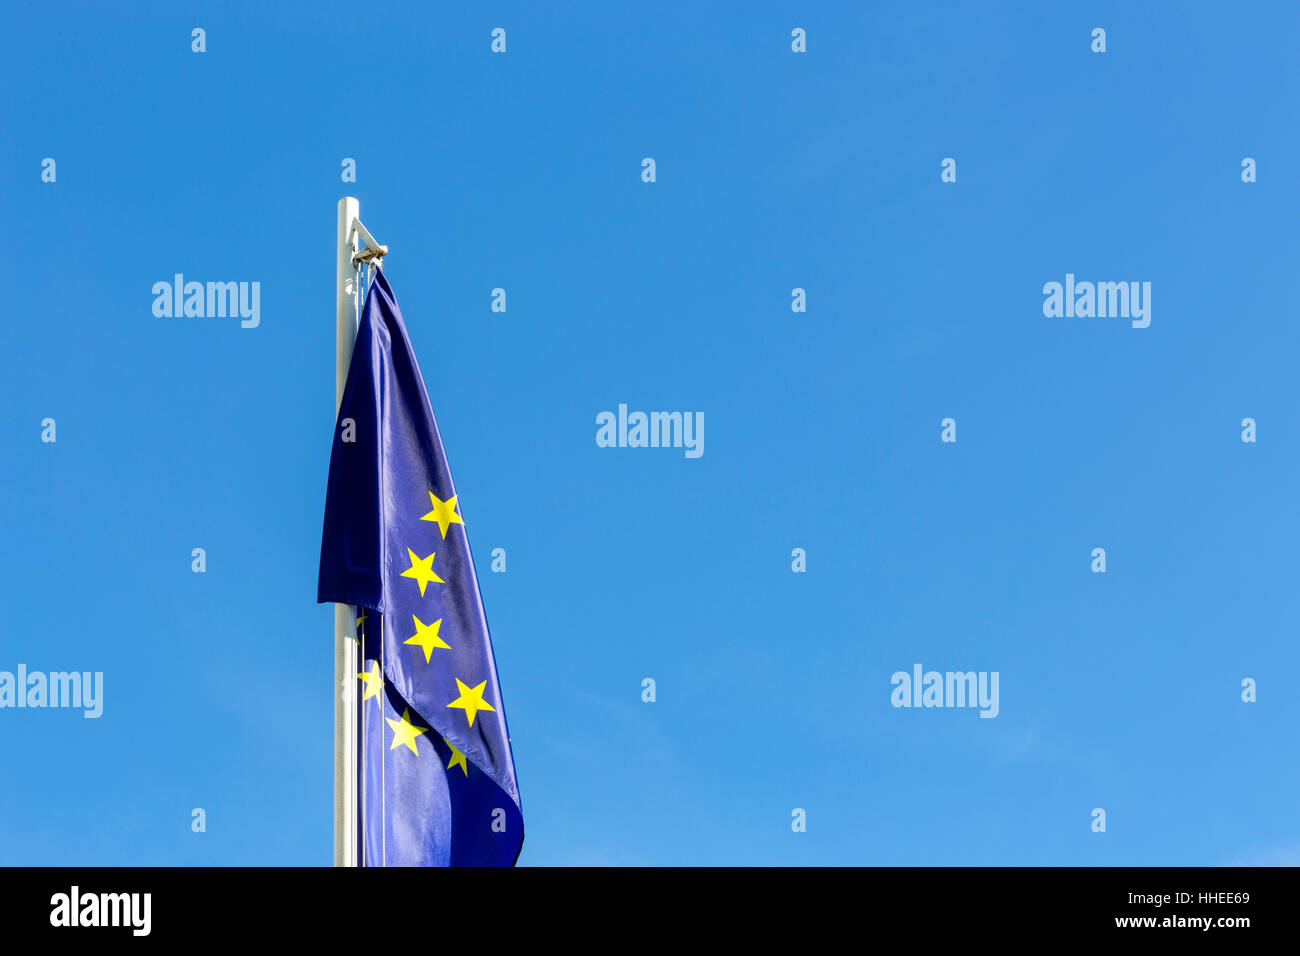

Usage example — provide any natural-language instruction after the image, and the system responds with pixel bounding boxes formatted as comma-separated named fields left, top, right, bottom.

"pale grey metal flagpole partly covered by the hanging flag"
left=334, top=196, right=361, bottom=866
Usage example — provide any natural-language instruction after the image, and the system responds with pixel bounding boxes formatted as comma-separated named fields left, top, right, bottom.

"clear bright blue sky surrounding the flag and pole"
left=0, top=3, right=1300, bottom=865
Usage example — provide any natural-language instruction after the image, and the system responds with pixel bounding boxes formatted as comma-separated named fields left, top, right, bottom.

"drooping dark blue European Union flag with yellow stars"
left=316, top=272, right=524, bottom=866
